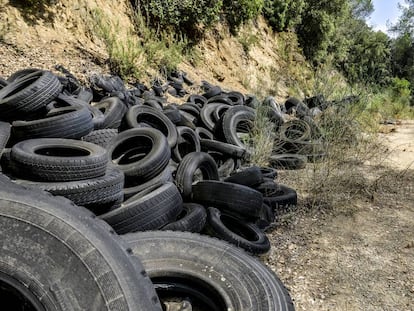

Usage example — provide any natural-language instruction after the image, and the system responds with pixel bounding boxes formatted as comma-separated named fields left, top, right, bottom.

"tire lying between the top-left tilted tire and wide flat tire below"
left=12, top=107, right=93, bottom=140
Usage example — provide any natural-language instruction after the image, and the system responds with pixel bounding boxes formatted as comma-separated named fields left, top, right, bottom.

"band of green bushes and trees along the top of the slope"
left=88, top=0, right=414, bottom=118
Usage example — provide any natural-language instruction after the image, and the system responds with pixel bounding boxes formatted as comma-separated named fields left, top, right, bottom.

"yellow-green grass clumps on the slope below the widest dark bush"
left=89, top=9, right=197, bottom=79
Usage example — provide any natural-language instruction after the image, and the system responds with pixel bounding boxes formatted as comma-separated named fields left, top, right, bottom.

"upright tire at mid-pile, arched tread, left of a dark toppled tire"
left=175, top=152, right=219, bottom=201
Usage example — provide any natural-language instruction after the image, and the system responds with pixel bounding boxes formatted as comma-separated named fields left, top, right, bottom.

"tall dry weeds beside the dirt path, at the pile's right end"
left=280, top=105, right=386, bottom=212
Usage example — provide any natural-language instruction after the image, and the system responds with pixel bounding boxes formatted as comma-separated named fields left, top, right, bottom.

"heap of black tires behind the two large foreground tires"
left=0, top=69, right=306, bottom=254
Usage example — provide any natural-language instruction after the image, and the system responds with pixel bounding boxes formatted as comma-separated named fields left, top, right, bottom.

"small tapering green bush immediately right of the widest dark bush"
left=223, top=0, right=264, bottom=33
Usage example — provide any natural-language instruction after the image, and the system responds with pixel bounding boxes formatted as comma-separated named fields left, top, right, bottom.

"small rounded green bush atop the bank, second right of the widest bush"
left=263, top=0, right=305, bottom=31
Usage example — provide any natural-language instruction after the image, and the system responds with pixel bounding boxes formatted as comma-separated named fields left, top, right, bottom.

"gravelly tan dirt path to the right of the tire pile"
left=267, top=121, right=414, bottom=311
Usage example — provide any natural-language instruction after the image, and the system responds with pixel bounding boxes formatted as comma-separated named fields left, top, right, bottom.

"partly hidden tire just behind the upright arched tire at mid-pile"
left=172, top=126, right=201, bottom=162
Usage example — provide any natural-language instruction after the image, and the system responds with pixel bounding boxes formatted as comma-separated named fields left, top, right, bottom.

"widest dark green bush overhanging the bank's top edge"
left=133, top=0, right=223, bottom=37
